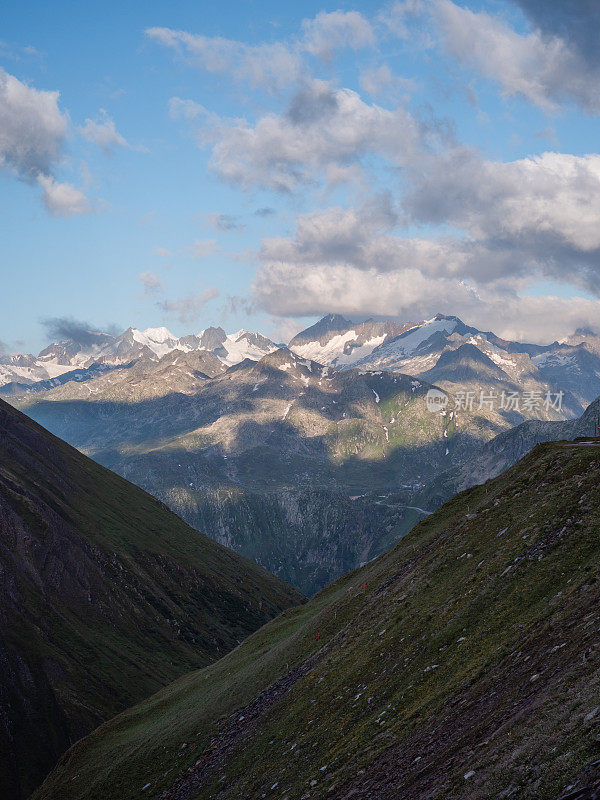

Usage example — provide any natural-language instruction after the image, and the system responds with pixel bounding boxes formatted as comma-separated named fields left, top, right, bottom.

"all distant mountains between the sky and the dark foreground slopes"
left=0, top=314, right=600, bottom=595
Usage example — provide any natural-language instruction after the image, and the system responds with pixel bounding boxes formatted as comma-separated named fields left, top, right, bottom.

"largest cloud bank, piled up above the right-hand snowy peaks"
left=254, top=169, right=600, bottom=340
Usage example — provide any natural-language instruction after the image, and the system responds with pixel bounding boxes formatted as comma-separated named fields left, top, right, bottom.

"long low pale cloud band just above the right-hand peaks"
left=254, top=264, right=600, bottom=342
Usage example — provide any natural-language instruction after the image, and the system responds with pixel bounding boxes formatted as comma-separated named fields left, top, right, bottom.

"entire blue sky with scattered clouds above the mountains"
left=0, top=0, right=600, bottom=352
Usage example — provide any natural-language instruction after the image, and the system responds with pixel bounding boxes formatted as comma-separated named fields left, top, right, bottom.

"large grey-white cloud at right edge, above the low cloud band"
left=404, top=148, right=600, bottom=292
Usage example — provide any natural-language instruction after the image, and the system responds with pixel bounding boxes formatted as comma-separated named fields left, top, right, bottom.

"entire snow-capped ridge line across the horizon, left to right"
left=5, top=314, right=600, bottom=417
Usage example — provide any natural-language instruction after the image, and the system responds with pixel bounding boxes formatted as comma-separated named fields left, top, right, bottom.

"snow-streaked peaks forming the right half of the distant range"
left=289, top=314, right=600, bottom=416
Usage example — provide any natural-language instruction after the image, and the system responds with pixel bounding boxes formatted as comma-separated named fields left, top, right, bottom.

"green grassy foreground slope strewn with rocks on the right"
left=34, top=444, right=600, bottom=800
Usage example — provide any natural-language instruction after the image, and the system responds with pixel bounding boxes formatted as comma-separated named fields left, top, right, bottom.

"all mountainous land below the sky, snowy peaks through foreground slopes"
left=0, top=315, right=600, bottom=800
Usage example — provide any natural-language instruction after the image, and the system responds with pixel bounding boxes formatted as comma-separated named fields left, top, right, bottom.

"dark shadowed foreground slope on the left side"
left=0, top=401, right=301, bottom=799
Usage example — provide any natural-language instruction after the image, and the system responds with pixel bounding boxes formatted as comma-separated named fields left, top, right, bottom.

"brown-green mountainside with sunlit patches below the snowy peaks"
left=14, top=348, right=505, bottom=594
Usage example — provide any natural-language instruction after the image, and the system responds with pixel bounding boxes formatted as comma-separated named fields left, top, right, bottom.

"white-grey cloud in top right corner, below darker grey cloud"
left=429, top=0, right=600, bottom=114
